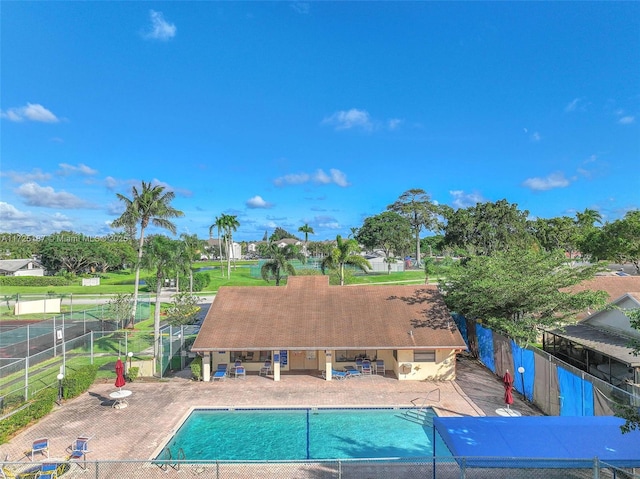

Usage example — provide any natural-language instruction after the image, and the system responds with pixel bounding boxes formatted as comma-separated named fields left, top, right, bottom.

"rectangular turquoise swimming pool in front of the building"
left=158, top=408, right=451, bottom=461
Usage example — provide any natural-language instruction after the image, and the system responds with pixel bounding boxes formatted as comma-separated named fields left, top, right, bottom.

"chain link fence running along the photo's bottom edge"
left=4, top=457, right=640, bottom=479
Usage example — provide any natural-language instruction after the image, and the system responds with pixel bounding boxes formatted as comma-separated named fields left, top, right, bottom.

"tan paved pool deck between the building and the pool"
left=0, top=357, right=542, bottom=463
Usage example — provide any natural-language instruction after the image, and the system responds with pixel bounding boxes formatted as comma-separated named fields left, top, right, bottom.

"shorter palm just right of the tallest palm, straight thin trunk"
left=142, top=235, right=179, bottom=373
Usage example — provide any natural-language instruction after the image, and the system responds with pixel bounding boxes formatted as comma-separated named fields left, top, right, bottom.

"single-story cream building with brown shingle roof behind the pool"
left=191, top=276, right=466, bottom=381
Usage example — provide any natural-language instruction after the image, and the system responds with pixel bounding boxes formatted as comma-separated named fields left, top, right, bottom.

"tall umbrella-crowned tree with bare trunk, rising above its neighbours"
left=387, top=188, right=438, bottom=268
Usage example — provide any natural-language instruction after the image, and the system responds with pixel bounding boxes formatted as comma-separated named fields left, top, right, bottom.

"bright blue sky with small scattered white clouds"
left=0, top=1, right=640, bottom=241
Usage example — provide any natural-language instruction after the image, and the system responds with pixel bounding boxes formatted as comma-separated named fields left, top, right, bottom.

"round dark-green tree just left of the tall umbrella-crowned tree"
left=355, top=211, right=411, bottom=273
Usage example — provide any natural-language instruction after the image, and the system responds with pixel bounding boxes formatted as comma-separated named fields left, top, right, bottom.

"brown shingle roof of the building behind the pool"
left=192, top=276, right=466, bottom=351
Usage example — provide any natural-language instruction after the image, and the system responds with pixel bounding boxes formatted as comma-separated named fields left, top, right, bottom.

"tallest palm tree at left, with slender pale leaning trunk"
left=111, top=181, right=184, bottom=327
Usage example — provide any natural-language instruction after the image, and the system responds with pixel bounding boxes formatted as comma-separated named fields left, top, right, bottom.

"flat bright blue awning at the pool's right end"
left=433, top=416, right=640, bottom=468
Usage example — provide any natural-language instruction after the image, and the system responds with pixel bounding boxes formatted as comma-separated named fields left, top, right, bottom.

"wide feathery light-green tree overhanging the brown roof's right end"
left=440, top=249, right=606, bottom=343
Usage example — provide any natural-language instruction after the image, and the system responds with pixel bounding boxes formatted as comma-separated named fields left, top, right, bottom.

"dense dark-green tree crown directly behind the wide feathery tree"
left=444, top=200, right=533, bottom=256
